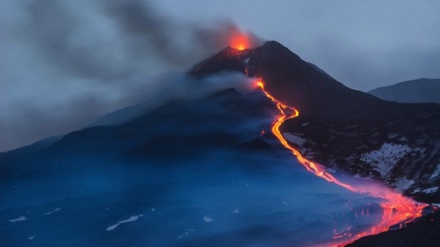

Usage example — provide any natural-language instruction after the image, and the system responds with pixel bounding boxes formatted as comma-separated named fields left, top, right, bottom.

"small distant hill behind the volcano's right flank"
left=368, top=78, right=440, bottom=103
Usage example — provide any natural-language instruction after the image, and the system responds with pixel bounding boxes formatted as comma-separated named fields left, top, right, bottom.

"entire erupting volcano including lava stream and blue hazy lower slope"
left=0, top=41, right=440, bottom=246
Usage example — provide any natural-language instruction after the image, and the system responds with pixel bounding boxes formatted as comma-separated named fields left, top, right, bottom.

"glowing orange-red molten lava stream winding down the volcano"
left=257, top=81, right=426, bottom=246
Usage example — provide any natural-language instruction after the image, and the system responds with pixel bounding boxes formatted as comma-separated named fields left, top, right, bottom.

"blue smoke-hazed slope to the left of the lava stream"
left=0, top=86, right=392, bottom=247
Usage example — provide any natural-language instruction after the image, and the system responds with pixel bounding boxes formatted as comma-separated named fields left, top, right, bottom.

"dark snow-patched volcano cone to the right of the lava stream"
left=189, top=41, right=440, bottom=202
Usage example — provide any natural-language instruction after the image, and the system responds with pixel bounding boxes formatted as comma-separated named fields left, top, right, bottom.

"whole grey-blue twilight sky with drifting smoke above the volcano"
left=0, top=0, right=440, bottom=151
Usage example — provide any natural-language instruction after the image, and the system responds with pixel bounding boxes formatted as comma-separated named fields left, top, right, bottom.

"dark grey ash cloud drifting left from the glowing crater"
left=0, top=0, right=257, bottom=152
